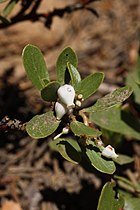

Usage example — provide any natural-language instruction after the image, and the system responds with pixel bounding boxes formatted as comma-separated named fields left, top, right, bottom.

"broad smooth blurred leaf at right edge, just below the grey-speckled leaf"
left=90, top=107, right=140, bottom=140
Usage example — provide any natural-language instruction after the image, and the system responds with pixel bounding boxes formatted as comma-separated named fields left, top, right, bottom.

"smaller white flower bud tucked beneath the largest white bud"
left=55, top=102, right=67, bottom=120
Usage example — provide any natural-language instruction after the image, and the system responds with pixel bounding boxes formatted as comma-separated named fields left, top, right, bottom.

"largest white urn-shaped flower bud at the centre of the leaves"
left=57, top=84, right=75, bottom=108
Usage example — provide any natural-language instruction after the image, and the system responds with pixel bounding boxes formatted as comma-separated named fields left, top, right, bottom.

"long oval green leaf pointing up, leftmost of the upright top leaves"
left=22, top=44, right=49, bottom=90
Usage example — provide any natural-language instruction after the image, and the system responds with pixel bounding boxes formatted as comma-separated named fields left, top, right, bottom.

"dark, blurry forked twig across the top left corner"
left=0, top=0, right=99, bottom=28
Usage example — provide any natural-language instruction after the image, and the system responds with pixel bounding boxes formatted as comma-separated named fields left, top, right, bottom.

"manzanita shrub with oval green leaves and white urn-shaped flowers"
left=22, top=45, right=140, bottom=210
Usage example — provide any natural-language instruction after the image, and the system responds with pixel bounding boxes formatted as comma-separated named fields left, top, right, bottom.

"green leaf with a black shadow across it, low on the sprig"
left=49, top=138, right=81, bottom=163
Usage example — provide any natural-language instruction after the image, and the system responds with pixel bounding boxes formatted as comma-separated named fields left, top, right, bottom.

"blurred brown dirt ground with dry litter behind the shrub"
left=0, top=0, right=140, bottom=210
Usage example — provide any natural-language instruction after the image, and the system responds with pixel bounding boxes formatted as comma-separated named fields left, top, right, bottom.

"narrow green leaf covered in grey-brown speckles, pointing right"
left=85, top=86, right=133, bottom=112
